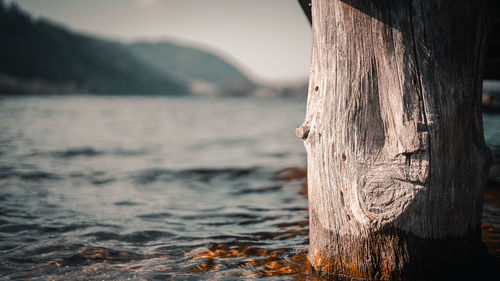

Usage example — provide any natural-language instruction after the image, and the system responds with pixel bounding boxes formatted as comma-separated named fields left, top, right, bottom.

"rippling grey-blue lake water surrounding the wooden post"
left=0, top=96, right=500, bottom=280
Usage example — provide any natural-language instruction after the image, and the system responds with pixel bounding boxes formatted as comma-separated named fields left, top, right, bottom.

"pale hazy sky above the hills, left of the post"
left=5, top=0, right=312, bottom=83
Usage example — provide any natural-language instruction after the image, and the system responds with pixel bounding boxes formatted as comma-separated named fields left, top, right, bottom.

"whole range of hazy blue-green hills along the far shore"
left=0, top=1, right=307, bottom=97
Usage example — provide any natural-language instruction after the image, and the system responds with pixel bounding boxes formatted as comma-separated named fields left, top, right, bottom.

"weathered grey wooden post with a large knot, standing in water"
left=297, top=0, right=491, bottom=279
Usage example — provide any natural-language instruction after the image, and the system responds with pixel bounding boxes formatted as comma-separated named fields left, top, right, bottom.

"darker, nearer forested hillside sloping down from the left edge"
left=0, top=2, right=187, bottom=95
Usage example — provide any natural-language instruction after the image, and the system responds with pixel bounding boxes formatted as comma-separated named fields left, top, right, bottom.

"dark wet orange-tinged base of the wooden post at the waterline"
left=308, top=223, right=488, bottom=280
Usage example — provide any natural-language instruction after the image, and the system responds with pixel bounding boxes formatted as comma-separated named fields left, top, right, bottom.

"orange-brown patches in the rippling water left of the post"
left=187, top=168, right=314, bottom=280
